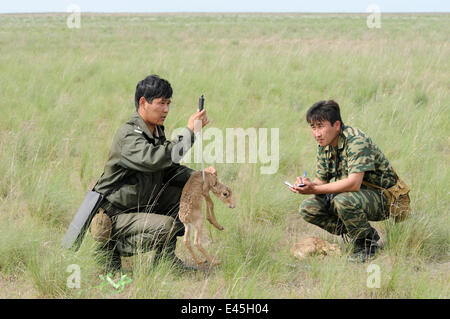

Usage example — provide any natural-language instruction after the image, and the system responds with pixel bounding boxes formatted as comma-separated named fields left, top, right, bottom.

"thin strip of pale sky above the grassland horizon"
left=0, top=0, right=450, bottom=13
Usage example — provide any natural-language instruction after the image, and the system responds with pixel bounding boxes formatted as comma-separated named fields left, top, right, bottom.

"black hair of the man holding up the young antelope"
left=134, top=74, right=173, bottom=110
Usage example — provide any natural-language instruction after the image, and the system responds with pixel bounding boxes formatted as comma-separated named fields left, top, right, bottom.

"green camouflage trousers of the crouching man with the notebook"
left=300, top=188, right=389, bottom=240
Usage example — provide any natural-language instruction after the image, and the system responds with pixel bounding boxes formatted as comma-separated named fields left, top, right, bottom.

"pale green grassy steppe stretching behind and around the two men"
left=0, top=14, right=450, bottom=298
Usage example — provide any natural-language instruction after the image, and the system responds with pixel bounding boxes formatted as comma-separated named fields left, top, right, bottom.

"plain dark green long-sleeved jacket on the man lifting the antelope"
left=94, top=112, right=194, bottom=215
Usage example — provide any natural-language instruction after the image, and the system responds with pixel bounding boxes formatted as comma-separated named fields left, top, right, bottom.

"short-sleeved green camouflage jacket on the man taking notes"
left=316, top=125, right=397, bottom=188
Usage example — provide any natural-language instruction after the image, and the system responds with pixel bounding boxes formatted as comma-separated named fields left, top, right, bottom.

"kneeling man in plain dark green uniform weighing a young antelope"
left=94, top=75, right=217, bottom=271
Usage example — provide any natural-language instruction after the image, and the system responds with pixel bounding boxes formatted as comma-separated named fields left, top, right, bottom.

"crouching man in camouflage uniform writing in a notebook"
left=290, top=100, right=397, bottom=261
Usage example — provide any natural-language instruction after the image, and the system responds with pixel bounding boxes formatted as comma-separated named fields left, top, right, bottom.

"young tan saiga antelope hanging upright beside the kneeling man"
left=178, top=171, right=235, bottom=266
